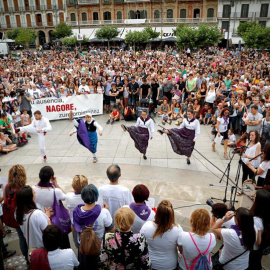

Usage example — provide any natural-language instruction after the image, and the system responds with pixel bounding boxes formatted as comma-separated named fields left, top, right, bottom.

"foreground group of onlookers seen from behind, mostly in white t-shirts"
left=0, top=162, right=270, bottom=270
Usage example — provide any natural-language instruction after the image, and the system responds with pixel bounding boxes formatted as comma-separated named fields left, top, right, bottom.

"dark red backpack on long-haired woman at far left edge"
left=3, top=184, right=19, bottom=228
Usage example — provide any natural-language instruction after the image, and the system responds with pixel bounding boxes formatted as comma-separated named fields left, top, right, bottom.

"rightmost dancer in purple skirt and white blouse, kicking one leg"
left=158, top=110, right=200, bottom=165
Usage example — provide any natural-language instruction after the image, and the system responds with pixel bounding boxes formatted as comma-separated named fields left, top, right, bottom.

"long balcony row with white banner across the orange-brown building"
left=68, top=18, right=217, bottom=26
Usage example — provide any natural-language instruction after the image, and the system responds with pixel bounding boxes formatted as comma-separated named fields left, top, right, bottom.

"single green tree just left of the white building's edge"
left=194, top=24, right=222, bottom=47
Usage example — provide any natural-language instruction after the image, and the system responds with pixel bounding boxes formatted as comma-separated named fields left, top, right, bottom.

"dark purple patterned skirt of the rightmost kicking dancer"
left=168, top=127, right=195, bottom=157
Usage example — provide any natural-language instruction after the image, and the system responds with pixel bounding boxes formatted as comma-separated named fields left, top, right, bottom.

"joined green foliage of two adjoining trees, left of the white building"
left=174, top=24, right=222, bottom=48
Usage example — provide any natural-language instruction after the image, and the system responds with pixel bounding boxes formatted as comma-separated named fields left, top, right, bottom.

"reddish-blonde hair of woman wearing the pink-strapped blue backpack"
left=190, top=209, right=210, bottom=236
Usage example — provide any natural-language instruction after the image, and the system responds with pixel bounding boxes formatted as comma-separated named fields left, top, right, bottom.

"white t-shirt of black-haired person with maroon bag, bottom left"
left=48, top=248, right=79, bottom=270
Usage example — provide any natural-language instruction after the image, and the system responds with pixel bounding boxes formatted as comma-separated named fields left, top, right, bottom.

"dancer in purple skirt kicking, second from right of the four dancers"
left=121, top=110, right=155, bottom=159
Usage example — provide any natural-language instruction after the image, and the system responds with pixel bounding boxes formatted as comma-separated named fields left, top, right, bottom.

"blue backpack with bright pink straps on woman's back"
left=183, top=233, right=212, bottom=270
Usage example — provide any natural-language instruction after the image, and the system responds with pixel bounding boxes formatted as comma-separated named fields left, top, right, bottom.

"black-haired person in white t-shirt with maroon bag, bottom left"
left=30, top=225, right=79, bottom=270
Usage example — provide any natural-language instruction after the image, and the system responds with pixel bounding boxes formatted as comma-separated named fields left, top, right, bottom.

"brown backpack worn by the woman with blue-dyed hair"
left=80, top=226, right=101, bottom=256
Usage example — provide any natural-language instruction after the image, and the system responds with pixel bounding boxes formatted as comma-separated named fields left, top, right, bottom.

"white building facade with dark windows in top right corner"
left=218, top=0, right=270, bottom=44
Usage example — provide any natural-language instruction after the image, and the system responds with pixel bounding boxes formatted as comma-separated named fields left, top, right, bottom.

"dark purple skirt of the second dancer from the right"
left=128, top=126, right=149, bottom=154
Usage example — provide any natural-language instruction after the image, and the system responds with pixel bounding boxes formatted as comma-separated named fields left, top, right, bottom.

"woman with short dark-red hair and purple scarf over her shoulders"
left=124, top=185, right=156, bottom=233
